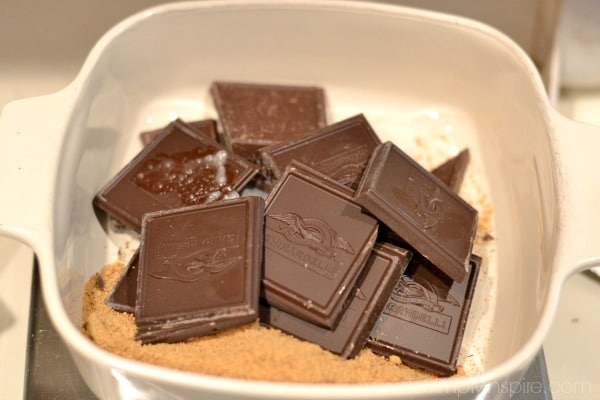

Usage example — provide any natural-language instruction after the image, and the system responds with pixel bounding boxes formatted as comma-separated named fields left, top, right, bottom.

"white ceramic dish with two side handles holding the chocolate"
left=0, top=1, right=600, bottom=399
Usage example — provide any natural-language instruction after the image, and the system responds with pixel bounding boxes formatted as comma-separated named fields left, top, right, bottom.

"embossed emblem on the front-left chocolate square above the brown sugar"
left=148, top=232, right=243, bottom=282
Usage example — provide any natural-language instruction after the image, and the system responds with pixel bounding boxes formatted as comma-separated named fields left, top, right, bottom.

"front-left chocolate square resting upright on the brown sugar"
left=135, top=196, right=264, bottom=343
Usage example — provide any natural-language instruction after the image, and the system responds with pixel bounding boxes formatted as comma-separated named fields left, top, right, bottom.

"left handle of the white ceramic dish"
left=0, top=91, right=68, bottom=253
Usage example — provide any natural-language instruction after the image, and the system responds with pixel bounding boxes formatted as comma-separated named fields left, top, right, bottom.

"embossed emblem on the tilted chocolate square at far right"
left=392, top=178, right=444, bottom=230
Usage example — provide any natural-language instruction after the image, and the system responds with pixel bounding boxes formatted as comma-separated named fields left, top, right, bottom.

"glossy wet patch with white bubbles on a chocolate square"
left=132, top=148, right=231, bottom=205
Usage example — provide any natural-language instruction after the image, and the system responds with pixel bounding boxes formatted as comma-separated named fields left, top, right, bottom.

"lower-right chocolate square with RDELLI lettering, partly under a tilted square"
left=367, top=254, right=481, bottom=376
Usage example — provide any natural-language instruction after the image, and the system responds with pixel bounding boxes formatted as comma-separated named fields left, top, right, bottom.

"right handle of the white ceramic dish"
left=552, top=112, right=600, bottom=281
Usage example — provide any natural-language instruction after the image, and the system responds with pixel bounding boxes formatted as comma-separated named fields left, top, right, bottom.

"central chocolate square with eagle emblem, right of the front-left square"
left=263, top=162, right=377, bottom=329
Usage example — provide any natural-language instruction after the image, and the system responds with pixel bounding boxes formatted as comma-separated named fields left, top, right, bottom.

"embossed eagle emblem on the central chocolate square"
left=265, top=213, right=354, bottom=279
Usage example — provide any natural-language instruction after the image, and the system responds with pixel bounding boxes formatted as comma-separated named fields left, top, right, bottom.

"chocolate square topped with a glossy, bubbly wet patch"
left=94, top=121, right=258, bottom=232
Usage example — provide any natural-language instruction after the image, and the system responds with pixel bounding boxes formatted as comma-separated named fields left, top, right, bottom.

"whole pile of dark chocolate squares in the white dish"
left=94, top=82, right=481, bottom=375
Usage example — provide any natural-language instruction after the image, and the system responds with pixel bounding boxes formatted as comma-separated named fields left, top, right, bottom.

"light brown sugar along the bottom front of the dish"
left=82, top=263, right=446, bottom=383
